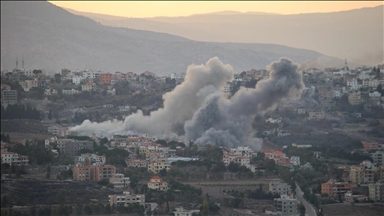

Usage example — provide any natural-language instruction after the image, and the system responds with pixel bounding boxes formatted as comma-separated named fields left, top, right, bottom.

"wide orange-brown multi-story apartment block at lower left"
left=73, top=164, right=116, bottom=181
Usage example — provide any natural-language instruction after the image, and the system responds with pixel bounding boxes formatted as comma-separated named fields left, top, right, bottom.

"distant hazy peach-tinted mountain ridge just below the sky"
left=70, top=6, right=384, bottom=65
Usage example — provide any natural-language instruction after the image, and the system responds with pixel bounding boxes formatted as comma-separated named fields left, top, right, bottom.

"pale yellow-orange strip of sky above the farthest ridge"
left=50, top=1, right=383, bottom=18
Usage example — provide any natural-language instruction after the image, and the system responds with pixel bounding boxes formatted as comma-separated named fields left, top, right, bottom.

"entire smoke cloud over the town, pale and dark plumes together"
left=70, top=57, right=304, bottom=150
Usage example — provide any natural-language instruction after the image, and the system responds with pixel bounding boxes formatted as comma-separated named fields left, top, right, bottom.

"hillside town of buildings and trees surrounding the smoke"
left=1, top=61, right=384, bottom=216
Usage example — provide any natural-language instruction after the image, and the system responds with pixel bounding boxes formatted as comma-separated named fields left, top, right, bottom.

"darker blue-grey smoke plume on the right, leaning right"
left=184, top=58, right=304, bottom=150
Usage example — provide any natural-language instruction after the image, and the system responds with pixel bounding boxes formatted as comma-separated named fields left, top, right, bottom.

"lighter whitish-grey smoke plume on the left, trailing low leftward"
left=70, top=57, right=233, bottom=136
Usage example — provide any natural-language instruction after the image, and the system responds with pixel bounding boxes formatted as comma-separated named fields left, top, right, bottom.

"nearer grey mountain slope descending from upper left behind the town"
left=1, top=1, right=343, bottom=75
